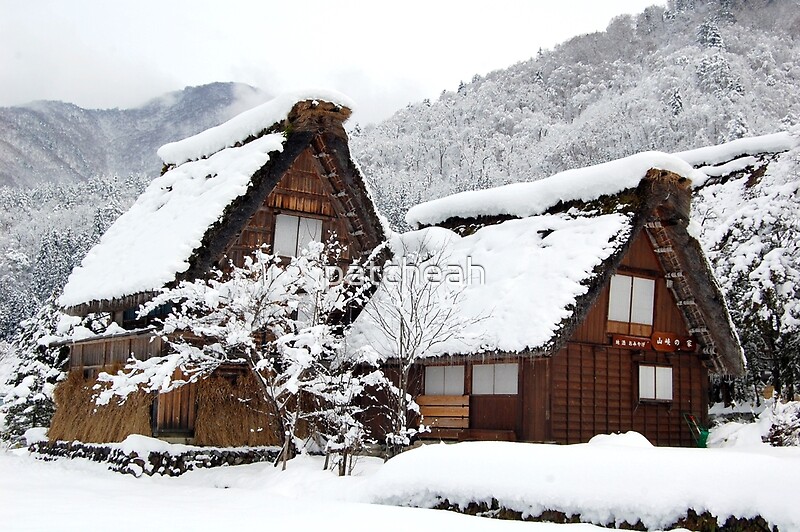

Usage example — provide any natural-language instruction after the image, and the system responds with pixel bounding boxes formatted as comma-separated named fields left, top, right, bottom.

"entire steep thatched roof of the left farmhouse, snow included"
left=59, top=94, right=384, bottom=314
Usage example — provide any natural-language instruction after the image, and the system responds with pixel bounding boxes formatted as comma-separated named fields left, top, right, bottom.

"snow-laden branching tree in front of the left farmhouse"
left=96, top=239, right=385, bottom=474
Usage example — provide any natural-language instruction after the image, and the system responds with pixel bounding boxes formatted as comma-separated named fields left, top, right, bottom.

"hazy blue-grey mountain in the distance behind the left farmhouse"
left=0, top=83, right=270, bottom=187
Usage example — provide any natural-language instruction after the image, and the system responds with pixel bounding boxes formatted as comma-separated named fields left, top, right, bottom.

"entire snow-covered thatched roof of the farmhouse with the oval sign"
left=351, top=152, right=742, bottom=373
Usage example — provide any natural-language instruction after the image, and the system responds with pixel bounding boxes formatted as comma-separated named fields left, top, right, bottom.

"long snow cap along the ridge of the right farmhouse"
left=406, top=151, right=707, bottom=226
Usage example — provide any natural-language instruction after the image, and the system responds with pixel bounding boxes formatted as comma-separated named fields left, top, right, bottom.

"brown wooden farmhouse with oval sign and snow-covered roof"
left=355, top=153, right=743, bottom=446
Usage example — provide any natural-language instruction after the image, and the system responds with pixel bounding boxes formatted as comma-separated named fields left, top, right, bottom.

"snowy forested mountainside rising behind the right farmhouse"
left=352, top=0, right=800, bottom=228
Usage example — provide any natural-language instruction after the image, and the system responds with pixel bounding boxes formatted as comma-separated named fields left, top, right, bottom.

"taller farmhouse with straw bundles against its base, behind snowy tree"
left=49, top=93, right=385, bottom=446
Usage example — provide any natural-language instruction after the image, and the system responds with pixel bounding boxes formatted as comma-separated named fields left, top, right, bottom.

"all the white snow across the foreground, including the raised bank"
left=0, top=433, right=800, bottom=532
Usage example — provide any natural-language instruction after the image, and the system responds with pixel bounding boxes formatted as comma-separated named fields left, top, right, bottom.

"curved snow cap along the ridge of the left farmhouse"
left=158, top=89, right=355, bottom=165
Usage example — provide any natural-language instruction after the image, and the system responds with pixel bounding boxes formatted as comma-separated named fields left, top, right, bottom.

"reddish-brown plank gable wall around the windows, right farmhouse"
left=522, top=230, right=708, bottom=446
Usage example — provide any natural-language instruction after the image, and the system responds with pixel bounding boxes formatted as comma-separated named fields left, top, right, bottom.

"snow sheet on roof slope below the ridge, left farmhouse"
left=59, top=133, right=284, bottom=306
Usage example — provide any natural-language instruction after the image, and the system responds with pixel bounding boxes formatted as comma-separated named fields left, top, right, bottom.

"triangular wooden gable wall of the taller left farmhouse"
left=226, top=146, right=361, bottom=265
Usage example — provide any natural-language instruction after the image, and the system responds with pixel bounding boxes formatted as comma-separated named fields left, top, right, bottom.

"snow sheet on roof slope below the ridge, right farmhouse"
left=352, top=211, right=633, bottom=356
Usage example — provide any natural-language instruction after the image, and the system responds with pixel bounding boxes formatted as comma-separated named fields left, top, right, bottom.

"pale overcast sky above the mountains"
left=0, top=0, right=666, bottom=122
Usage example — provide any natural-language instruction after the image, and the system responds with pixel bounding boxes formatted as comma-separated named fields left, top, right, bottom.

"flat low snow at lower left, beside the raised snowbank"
left=0, top=444, right=603, bottom=532
